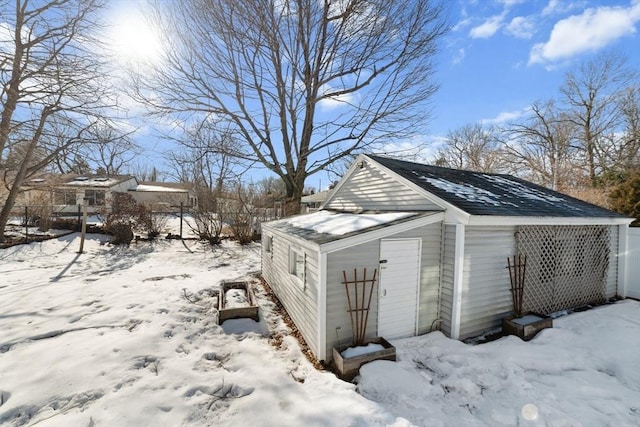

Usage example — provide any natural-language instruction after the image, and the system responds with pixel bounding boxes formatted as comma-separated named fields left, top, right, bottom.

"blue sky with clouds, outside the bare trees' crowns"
left=107, top=0, right=640, bottom=189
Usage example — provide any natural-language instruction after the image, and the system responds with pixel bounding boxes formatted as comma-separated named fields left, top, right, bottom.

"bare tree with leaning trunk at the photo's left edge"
left=0, top=0, right=116, bottom=241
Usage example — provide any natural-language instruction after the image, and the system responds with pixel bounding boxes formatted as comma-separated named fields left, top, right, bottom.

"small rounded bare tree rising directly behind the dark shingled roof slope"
left=436, top=123, right=504, bottom=173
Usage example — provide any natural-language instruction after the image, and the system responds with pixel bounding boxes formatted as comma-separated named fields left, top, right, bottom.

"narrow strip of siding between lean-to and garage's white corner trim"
left=439, top=224, right=456, bottom=336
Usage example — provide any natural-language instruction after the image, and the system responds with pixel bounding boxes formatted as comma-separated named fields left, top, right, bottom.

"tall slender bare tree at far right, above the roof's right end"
left=560, top=52, right=634, bottom=186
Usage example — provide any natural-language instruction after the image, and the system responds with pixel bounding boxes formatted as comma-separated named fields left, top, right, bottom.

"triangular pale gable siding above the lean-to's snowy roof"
left=325, top=164, right=442, bottom=211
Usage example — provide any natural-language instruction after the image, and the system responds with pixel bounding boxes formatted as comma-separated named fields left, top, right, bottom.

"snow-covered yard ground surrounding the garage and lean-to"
left=0, top=234, right=640, bottom=426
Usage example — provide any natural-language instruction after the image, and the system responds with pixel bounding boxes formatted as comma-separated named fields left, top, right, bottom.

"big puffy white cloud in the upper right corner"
left=529, top=1, right=640, bottom=65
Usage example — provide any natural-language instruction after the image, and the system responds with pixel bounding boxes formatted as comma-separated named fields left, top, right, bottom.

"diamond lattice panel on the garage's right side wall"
left=516, top=225, right=610, bottom=314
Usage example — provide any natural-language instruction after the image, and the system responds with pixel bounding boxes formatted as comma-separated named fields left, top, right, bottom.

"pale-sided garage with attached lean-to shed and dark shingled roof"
left=262, top=155, right=632, bottom=360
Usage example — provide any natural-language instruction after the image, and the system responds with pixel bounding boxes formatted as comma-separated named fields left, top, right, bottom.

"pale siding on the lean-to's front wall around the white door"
left=326, top=223, right=441, bottom=358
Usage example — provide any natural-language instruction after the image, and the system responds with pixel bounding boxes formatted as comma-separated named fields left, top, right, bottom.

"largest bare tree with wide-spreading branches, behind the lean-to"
left=138, top=0, right=447, bottom=212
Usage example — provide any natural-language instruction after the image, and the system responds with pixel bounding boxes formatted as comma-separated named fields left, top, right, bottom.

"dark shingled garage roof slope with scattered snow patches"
left=368, top=156, right=625, bottom=218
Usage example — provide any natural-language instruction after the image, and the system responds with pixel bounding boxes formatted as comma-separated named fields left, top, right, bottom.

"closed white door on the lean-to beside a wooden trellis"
left=378, top=239, right=421, bottom=339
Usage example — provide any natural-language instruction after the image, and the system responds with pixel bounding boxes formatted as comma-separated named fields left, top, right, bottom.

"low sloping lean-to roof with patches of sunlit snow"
left=263, top=210, right=436, bottom=244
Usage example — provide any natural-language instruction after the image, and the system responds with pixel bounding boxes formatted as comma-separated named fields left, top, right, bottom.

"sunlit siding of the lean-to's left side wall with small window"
left=262, top=231, right=319, bottom=355
